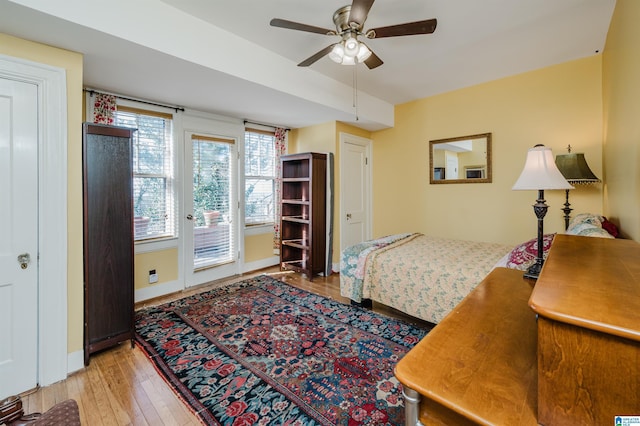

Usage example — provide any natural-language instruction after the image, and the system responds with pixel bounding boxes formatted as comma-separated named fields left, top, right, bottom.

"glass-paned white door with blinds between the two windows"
left=185, top=132, right=238, bottom=286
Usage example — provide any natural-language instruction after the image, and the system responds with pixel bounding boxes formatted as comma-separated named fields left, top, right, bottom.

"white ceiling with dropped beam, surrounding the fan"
left=0, top=0, right=615, bottom=130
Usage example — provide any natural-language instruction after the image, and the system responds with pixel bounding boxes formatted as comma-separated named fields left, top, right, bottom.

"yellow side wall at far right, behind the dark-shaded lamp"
left=603, top=0, right=640, bottom=241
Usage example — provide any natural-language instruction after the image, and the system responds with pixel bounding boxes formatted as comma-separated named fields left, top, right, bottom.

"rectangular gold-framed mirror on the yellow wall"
left=429, top=133, right=491, bottom=184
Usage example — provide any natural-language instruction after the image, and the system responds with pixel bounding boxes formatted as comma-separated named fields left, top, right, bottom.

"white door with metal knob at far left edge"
left=0, top=79, right=38, bottom=399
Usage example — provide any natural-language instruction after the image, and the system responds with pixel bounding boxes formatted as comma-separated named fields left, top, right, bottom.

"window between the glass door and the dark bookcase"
left=244, top=129, right=276, bottom=226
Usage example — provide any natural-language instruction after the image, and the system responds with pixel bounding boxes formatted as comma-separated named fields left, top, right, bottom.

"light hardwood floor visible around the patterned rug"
left=22, top=267, right=426, bottom=426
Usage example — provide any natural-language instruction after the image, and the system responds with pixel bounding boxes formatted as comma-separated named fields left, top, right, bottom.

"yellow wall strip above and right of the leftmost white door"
left=0, top=33, right=84, bottom=353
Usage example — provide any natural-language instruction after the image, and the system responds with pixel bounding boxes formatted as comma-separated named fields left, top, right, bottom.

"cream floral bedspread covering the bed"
left=340, top=234, right=513, bottom=324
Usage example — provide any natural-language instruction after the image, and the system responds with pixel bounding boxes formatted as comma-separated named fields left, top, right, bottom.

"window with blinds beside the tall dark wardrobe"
left=114, top=105, right=176, bottom=241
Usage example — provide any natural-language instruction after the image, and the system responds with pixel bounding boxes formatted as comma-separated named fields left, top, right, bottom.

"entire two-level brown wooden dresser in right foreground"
left=396, top=235, right=640, bottom=426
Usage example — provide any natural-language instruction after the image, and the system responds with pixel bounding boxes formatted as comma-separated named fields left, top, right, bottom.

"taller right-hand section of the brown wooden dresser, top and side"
left=529, top=235, right=640, bottom=425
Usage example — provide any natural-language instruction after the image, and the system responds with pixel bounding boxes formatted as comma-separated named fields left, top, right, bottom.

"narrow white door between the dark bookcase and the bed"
left=340, top=133, right=371, bottom=251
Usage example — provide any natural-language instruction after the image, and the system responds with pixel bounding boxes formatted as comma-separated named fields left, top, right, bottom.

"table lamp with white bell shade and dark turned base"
left=512, top=144, right=573, bottom=279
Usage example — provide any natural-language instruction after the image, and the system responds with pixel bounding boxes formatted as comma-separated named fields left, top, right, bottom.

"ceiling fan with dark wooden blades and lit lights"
left=270, top=0, right=437, bottom=69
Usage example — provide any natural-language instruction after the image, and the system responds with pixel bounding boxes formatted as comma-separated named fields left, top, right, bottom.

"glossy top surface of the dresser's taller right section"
left=529, top=234, right=640, bottom=341
